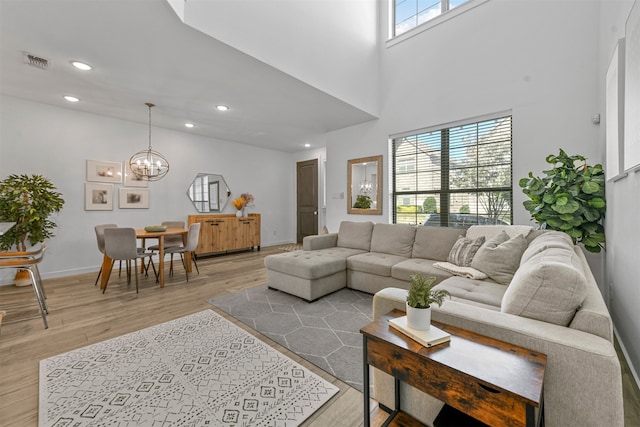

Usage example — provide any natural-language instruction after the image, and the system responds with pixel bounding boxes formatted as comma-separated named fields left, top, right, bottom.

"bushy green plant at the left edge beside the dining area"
left=0, top=175, right=64, bottom=252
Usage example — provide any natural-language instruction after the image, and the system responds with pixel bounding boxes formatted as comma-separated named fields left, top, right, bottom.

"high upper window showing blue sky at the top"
left=392, top=0, right=469, bottom=37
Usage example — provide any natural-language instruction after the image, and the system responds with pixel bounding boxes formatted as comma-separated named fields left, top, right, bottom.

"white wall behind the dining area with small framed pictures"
left=0, top=96, right=295, bottom=279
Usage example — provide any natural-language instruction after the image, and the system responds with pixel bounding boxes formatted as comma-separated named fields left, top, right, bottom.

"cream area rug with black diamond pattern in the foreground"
left=38, top=310, right=338, bottom=427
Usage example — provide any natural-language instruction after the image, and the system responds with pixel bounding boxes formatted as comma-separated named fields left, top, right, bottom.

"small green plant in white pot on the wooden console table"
left=407, top=273, right=451, bottom=331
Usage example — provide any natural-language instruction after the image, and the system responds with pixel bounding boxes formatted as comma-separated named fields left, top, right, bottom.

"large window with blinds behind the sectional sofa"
left=391, top=116, right=513, bottom=228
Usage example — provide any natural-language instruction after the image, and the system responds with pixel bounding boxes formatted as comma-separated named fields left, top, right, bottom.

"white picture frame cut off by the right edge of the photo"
left=624, top=0, right=640, bottom=172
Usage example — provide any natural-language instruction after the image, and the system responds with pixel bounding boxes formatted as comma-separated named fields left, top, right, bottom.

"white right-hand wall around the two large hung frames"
left=598, top=0, right=640, bottom=384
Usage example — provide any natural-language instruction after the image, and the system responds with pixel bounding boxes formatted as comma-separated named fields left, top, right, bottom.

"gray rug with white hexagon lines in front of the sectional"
left=209, top=285, right=373, bottom=391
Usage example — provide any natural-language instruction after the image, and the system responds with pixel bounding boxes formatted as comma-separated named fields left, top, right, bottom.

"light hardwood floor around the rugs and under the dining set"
left=0, top=247, right=640, bottom=427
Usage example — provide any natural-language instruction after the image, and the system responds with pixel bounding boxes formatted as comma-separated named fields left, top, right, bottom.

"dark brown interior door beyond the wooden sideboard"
left=296, top=159, right=318, bottom=243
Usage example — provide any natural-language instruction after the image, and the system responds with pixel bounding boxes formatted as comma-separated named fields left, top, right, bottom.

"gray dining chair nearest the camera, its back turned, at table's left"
left=102, top=227, right=158, bottom=293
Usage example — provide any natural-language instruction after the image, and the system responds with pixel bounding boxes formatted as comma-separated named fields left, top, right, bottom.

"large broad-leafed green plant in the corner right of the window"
left=519, top=149, right=606, bottom=252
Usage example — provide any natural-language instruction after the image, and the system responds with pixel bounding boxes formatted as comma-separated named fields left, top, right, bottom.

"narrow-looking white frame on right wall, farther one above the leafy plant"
left=605, top=38, right=626, bottom=181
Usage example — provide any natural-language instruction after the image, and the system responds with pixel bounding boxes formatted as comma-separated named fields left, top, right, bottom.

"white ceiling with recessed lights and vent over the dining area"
left=0, top=0, right=374, bottom=152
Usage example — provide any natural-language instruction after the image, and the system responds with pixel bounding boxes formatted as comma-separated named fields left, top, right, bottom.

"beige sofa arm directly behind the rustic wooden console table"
left=373, top=288, right=624, bottom=426
